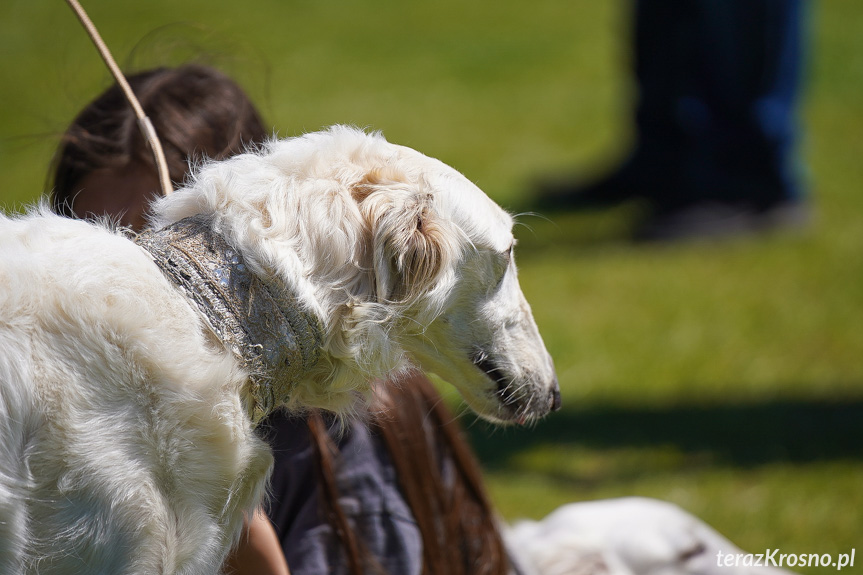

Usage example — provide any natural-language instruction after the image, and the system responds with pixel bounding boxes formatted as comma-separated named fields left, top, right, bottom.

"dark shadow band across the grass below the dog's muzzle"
left=468, top=398, right=863, bottom=469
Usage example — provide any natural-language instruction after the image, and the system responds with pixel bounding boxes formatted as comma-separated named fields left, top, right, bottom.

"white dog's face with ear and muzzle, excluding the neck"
left=353, top=137, right=560, bottom=423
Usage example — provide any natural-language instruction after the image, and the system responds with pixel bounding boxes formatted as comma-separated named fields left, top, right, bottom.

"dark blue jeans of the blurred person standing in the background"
left=631, top=0, right=805, bottom=208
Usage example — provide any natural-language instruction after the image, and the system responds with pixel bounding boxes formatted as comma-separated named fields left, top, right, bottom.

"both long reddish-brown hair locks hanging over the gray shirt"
left=309, top=373, right=510, bottom=575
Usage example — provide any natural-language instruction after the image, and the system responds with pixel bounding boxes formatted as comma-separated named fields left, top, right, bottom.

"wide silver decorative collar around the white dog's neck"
left=135, top=216, right=323, bottom=425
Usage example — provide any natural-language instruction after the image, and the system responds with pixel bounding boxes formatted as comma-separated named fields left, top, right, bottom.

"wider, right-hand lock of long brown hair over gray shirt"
left=378, top=374, right=509, bottom=575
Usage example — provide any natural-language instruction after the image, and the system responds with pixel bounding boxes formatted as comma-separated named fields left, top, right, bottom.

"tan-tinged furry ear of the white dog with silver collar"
left=353, top=171, right=454, bottom=302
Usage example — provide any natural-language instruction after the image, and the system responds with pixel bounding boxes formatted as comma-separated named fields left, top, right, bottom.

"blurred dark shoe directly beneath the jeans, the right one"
left=635, top=200, right=811, bottom=242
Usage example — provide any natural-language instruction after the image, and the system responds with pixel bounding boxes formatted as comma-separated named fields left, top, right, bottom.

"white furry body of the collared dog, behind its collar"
left=0, top=213, right=270, bottom=574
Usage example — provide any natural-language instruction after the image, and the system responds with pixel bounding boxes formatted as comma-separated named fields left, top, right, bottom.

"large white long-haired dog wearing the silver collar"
left=0, top=127, right=560, bottom=574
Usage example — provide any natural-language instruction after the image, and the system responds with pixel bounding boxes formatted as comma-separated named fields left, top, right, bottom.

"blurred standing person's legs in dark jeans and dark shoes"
left=538, top=0, right=808, bottom=240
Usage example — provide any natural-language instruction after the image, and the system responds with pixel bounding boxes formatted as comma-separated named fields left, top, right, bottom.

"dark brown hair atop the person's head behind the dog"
left=49, top=64, right=267, bottom=216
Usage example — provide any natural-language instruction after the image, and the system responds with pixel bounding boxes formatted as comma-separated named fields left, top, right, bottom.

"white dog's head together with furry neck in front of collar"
left=154, top=127, right=560, bottom=423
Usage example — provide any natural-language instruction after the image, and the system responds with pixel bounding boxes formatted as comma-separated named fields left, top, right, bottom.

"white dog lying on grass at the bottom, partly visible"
left=504, top=497, right=796, bottom=575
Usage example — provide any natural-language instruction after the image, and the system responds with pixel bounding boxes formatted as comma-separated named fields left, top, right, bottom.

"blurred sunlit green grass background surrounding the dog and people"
left=0, top=0, right=863, bottom=573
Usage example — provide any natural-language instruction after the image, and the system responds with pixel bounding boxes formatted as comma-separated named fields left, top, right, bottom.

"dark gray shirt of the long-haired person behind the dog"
left=262, top=414, right=422, bottom=575
